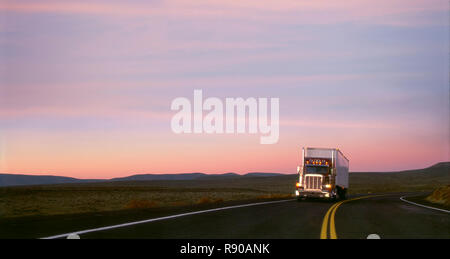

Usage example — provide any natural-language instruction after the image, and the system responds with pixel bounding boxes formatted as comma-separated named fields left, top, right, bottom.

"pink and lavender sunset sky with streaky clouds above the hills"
left=0, top=0, right=450, bottom=178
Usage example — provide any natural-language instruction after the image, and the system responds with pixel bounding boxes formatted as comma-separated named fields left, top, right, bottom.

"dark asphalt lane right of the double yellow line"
left=335, top=194, right=450, bottom=239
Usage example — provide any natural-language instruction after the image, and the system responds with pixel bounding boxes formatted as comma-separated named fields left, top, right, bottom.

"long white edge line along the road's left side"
left=41, top=199, right=295, bottom=239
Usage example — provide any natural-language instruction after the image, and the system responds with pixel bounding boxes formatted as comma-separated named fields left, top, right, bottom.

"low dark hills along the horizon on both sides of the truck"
left=0, top=162, right=450, bottom=191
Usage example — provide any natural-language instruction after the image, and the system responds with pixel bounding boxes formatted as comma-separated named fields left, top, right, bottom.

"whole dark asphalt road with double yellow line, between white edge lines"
left=68, top=193, right=450, bottom=239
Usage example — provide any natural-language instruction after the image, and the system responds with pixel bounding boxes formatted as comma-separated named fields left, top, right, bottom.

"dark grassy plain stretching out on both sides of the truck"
left=0, top=163, right=450, bottom=219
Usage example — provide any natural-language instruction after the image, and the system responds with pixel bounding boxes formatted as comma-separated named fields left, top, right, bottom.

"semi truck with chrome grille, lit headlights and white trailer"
left=295, top=147, right=349, bottom=201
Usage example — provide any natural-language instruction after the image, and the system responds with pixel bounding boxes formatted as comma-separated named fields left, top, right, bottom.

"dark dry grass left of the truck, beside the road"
left=0, top=176, right=295, bottom=218
